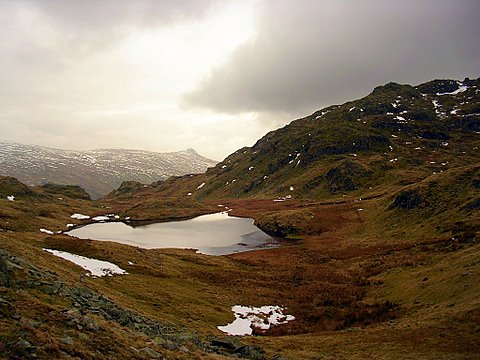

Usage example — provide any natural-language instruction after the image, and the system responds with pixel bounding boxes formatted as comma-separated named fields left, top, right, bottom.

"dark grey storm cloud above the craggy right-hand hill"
left=184, top=0, right=480, bottom=115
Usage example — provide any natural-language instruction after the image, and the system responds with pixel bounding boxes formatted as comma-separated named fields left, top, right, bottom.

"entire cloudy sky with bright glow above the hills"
left=0, top=0, right=480, bottom=160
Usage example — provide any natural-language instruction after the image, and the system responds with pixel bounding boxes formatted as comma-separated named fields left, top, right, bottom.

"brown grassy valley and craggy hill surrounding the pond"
left=0, top=79, right=480, bottom=360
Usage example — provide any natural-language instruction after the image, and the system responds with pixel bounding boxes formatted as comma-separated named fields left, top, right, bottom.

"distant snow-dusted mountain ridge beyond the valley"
left=0, top=140, right=217, bottom=198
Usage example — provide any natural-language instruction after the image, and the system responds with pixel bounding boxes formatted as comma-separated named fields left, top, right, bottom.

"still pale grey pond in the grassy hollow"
left=67, top=213, right=278, bottom=255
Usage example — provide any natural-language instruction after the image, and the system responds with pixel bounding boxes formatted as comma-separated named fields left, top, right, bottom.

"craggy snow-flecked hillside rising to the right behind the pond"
left=120, top=79, right=480, bottom=204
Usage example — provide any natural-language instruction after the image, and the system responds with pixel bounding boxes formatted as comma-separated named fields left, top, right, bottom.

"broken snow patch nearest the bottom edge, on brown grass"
left=218, top=305, right=295, bottom=336
